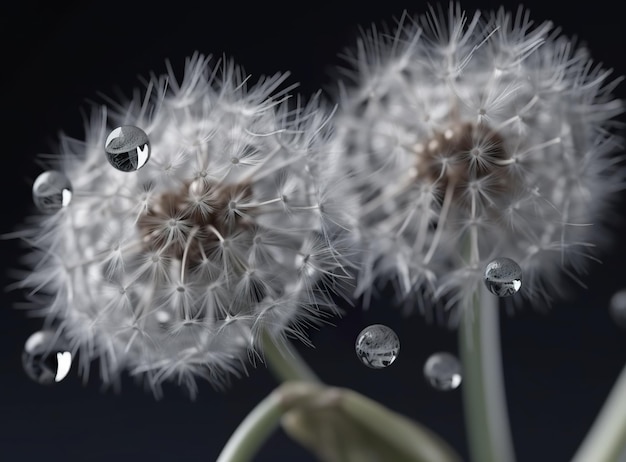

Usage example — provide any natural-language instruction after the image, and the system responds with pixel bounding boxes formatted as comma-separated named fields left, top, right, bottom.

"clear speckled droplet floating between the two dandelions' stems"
left=355, top=324, right=400, bottom=369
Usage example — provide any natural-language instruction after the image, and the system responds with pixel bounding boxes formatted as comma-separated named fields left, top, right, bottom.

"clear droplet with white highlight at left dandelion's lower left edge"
left=22, top=330, right=72, bottom=385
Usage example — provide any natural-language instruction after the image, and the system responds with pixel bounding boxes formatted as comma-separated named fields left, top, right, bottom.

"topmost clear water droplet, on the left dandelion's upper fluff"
left=104, top=125, right=150, bottom=172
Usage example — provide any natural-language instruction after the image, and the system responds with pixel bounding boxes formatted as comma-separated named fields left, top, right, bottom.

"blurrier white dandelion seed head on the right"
left=336, top=3, right=625, bottom=319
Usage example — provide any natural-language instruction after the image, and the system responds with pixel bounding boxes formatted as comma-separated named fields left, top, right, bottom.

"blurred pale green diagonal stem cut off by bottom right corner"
left=572, top=366, right=626, bottom=462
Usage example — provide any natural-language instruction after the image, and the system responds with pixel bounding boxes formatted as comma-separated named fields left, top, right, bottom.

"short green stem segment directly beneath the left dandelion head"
left=261, top=331, right=322, bottom=383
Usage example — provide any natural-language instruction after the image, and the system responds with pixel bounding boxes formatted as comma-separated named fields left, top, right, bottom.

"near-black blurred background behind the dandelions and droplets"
left=0, top=0, right=626, bottom=462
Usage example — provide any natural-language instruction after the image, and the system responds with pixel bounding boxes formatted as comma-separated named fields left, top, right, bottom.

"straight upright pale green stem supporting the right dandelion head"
left=459, top=284, right=515, bottom=462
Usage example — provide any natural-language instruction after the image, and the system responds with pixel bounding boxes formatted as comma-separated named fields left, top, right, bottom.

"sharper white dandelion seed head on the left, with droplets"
left=9, top=54, right=354, bottom=396
